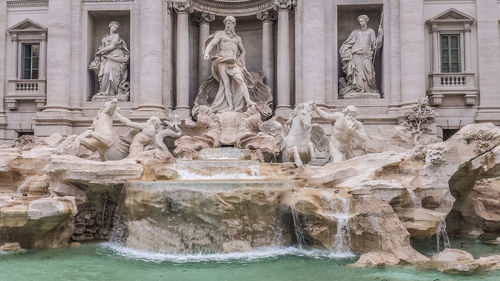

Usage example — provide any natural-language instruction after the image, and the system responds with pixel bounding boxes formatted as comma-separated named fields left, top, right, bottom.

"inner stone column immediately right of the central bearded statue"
left=257, top=10, right=276, bottom=90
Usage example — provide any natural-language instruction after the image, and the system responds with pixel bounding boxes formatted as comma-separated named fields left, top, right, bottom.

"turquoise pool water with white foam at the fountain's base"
left=0, top=242, right=500, bottom=281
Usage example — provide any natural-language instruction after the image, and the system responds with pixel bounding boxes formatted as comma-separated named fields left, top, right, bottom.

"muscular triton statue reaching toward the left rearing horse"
left=115, top=111, right=161, bottom=158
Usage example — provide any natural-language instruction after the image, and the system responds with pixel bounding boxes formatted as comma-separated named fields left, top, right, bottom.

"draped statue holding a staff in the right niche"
left=339, top=15, right=383, bottom=98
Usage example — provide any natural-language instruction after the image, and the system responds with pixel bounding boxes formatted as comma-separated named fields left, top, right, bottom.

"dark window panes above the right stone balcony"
left=441, top=34, right=462, bottom=73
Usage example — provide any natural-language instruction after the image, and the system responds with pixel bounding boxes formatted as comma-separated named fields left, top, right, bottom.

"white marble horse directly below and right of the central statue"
left=283, top=103, right=315, bottom=167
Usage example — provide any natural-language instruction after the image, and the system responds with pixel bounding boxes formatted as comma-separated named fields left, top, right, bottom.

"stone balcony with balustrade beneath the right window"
left=429, top=73, right=478, bottom=106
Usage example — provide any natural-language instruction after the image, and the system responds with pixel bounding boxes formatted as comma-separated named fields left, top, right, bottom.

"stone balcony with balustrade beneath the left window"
left=5, top=79, right=47, bottom=110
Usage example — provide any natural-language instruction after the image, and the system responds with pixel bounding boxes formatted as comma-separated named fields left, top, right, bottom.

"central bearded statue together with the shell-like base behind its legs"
left=193, top=16, right=272, bottom=119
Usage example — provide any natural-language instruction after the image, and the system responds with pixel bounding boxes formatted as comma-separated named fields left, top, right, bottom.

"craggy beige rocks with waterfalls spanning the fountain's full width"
left=0, top=121, right=500, bottom=272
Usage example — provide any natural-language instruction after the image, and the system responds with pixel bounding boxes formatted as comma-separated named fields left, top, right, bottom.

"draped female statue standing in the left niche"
left=89, top=21, right=130, bottom=101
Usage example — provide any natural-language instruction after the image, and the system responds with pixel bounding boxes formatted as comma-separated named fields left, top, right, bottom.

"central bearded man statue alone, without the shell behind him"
left=204, top=16, right=255, bottom=113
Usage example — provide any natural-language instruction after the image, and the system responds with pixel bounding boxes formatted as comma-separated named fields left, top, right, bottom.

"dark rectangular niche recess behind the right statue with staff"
left=336, top=4, right=387, bottom=99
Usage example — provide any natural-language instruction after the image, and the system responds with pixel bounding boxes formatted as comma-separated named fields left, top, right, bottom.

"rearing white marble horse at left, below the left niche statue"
left=76, top=99, right=118, bottom=161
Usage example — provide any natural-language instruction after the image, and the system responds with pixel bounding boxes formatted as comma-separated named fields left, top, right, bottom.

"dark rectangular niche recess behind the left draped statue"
left=86, top=10, right=132, bottom=101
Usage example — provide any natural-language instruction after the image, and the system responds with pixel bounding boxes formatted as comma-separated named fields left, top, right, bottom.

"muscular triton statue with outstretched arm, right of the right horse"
left=312, top=104, right=369, bottom=163
